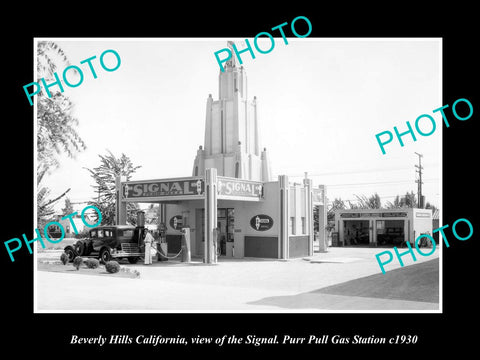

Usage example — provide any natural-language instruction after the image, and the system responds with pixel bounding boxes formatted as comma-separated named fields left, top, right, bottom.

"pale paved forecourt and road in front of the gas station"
left=37, top=248, right=439, bottom=312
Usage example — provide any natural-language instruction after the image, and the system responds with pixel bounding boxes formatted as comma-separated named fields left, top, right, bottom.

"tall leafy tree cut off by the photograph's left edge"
left=37, top=41, right=86, bottom=224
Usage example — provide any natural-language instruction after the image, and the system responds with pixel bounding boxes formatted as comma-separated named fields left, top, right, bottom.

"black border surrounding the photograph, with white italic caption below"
left=0, top=2, right=480, bottom=358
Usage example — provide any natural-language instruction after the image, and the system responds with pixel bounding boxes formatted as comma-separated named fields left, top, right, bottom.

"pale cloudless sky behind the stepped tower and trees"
left=32, top=38, right=444, bottom=211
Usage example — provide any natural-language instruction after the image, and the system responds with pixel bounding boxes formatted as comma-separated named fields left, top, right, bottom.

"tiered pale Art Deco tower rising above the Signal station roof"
left=193, top=41, right=271, bottom=182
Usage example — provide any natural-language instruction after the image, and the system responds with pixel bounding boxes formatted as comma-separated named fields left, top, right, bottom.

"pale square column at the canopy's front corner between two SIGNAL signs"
left=203, top=168, right=217, bottom=264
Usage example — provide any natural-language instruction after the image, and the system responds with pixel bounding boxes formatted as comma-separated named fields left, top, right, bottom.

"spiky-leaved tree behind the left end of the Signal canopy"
left=84, top=150, right=141, bottom=225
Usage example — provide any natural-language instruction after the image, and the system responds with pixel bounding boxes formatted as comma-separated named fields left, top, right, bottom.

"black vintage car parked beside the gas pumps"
left=64, top=225, right=144, bottom=264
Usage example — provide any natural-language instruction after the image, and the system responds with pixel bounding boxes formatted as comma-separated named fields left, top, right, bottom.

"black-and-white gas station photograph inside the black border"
left=32, top=37, right=440, bottom=313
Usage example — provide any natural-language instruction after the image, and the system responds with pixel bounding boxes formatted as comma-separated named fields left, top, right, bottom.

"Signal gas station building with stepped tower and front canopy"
left=116, top=43, right=326, bottom=263
